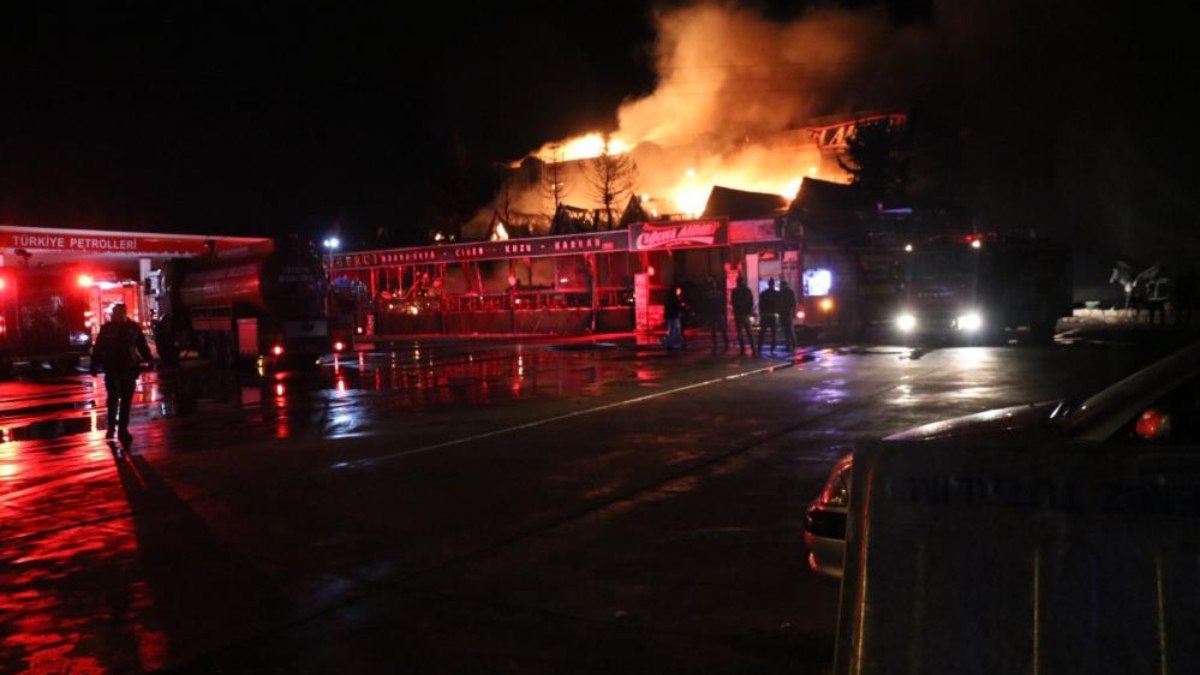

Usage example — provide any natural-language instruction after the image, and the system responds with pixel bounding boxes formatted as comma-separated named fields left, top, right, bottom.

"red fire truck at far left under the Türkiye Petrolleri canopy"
left=0, top=264, right=96, bottom=372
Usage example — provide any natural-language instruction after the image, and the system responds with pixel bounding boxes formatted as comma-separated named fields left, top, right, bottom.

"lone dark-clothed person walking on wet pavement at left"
left=90, top=303, right=154, bottom=443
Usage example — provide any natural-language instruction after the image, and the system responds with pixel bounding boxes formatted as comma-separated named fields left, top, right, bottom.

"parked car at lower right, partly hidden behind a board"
left=804, top=342, right=1200, bottom=578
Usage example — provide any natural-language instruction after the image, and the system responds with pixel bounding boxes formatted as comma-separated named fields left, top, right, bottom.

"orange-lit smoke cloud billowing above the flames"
left=618, top=2, right=923, bottom=144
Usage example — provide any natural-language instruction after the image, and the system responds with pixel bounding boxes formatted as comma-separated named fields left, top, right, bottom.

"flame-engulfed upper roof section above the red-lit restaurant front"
left=464, top=112, right=905, bottom=239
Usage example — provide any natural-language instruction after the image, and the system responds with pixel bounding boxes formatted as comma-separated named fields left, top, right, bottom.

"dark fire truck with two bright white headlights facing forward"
left=802, top=232, right=1073, bottom=344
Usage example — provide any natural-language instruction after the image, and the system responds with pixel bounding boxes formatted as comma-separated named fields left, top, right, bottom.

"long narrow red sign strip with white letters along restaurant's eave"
left=334, top=229, right=629, bottom=269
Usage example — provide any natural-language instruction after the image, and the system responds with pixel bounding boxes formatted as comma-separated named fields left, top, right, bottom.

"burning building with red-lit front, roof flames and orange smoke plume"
left=324, top=2, right=921, bottom=334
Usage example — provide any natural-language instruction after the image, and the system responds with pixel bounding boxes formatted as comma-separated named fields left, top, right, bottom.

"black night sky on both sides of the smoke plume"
left=0, top=0, right=1200, bottom=273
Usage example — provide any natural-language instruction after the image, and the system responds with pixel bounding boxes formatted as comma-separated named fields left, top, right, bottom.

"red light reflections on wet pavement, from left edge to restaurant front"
left=0, top=338, right=787, bottom=673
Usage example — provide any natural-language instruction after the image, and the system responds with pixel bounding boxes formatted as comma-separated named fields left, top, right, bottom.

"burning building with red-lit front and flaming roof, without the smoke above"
left=324, top=113, right=904, bottom=335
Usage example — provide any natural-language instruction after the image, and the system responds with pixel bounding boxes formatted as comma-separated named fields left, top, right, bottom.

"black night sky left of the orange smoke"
left=0, top=1, right=667, bottom=243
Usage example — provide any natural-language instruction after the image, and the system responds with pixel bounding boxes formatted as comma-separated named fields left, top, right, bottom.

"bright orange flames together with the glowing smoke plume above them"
left=496, top=2, right=926, bottom=228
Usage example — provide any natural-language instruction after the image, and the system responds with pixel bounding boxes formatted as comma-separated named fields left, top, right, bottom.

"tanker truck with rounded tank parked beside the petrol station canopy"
left=155, top=246, right=330, bottom=368
